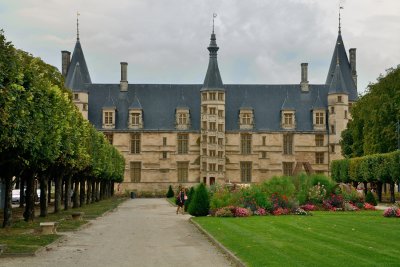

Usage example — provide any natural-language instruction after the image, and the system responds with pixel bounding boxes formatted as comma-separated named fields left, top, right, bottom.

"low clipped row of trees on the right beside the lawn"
left=331, top=150, right=400, bottom=202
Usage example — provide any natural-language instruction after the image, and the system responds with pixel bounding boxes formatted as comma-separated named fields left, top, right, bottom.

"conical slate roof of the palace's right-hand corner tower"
left=326, top=30, right=358, bottom=101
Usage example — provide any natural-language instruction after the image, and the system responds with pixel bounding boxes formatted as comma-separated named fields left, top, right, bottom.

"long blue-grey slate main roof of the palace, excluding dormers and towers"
left=88, top=84, right=329, bottom=132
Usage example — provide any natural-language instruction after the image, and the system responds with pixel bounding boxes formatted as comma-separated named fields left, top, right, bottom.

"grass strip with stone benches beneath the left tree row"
left=0, top=197, right=125, bottom=255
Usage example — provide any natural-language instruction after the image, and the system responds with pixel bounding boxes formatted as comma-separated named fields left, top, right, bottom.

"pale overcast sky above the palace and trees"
left=0, top=0, right=400, bottom=92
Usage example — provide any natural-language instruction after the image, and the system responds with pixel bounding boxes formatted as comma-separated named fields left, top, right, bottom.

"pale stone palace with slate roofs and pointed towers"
left=62, top=17, right=358, bottom=192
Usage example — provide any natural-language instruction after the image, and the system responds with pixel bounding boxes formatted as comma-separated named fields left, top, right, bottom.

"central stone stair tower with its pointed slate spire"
left=200, top=14, right=225, bottom=185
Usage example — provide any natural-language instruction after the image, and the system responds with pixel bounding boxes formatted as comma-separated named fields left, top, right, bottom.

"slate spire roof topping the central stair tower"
left=201, top=30, right=225, bottom=91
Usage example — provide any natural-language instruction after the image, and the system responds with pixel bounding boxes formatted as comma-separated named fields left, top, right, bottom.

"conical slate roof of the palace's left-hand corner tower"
left=65, top=39, right=92, bottom=91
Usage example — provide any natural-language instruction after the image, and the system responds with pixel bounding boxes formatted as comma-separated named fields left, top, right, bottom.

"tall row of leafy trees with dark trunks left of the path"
left=0, top=31, right=125, bottom=227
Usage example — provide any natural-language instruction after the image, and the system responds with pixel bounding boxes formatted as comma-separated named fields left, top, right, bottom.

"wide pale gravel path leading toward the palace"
left=0, top=199, right=231, bottom=267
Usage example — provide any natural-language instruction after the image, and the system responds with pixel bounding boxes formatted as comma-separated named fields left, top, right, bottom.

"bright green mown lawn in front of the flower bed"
left=194, top=211, right=400, bottom=266
